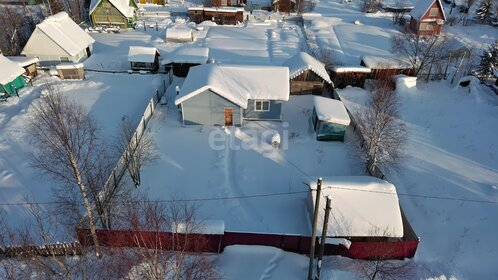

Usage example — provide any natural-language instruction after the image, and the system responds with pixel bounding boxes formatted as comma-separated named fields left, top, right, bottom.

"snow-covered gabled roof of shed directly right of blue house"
left=283, top=52, right=332, bottom=84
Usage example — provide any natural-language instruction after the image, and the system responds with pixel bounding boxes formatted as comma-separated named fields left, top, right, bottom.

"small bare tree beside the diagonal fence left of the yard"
left=115, top=117, right=157, bottom=187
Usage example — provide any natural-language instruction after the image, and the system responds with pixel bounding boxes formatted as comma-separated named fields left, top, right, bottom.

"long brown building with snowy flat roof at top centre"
left=188, top=7, right=244, bottom=25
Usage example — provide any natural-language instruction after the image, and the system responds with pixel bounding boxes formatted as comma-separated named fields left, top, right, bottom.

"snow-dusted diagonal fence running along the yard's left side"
left=101, top=77, right=170, bottom=196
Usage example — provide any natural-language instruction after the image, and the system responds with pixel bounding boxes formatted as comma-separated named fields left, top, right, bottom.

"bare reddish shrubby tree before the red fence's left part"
left=104, top=201, right=218, bottom=280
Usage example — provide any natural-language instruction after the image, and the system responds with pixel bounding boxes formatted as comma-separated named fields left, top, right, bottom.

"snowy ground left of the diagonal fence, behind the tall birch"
left=0, top=72, right=163, bottom=228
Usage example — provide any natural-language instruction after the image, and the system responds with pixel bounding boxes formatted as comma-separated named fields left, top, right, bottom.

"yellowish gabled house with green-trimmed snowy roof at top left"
left=89, top=0, right=138, bottom=28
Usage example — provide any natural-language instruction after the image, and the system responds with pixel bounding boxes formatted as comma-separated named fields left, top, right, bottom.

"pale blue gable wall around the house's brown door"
left=182, top=90, right=242, bottom=126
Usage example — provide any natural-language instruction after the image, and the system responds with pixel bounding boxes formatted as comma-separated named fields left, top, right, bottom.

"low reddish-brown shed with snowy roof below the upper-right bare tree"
left=360, top=55, right=413, bottom=79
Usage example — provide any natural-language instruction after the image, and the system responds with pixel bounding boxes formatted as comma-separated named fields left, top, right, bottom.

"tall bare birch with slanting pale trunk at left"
left=28, top=84, right=100, bottom=257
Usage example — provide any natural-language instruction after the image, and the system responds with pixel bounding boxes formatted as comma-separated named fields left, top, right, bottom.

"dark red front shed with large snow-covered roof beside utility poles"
left=307, top=176, right=419, bottom=259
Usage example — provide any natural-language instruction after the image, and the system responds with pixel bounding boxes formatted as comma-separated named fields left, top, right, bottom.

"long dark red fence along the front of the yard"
left=77, top=219, right=419, bottom=259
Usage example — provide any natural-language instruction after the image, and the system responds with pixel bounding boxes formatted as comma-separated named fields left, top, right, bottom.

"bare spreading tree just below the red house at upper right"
left=391, top=32, right=451, bottom=76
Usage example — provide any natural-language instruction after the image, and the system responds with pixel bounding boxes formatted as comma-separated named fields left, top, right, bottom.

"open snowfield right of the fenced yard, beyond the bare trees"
left=338, top=79, right=498, bottom=279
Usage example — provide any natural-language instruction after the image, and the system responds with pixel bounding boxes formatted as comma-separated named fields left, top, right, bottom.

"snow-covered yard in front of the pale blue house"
left=140, top=76, right=364, bottom=235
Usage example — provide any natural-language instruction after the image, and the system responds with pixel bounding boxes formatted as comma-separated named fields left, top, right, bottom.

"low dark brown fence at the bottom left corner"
left=0, top=242, right=81, bottom=258
